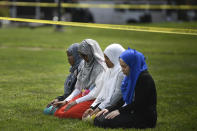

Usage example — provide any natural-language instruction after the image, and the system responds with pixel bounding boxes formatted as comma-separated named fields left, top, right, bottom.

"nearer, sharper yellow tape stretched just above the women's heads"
left=0, top=17, right=197, bottom=35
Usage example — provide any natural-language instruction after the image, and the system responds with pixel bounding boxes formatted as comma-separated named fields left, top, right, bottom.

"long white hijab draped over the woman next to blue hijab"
left=92, top=44, right=125, bottom=106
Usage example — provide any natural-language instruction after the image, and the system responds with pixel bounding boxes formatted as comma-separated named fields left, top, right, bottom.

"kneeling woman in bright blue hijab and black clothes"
left=94, top=48, right=157, bottom=128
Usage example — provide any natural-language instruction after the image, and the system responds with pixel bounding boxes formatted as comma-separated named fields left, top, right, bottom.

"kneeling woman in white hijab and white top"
left=83, top=44, right=125, bottom=119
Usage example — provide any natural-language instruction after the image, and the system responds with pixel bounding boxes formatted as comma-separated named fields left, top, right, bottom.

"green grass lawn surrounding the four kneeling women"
left=0, top=23, right=197, bottom=131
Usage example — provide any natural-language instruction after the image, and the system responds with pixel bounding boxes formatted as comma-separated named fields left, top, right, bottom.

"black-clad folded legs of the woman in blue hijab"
left=94, top=113, right=155, bottom=128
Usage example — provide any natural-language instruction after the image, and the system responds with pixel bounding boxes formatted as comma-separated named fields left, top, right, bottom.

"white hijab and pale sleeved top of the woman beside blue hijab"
left=92, top=44, right=125, bottom=109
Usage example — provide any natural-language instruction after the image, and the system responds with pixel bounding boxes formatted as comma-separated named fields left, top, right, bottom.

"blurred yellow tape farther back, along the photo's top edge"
left=0, top=1, right=197, bottom=10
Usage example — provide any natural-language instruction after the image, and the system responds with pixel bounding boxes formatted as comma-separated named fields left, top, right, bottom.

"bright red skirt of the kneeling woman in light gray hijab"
left=54, top=93, right=94, bottom=119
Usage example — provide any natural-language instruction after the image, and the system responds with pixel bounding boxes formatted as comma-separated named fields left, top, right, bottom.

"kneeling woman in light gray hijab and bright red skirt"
left=54, top=39, right=106, bottom=119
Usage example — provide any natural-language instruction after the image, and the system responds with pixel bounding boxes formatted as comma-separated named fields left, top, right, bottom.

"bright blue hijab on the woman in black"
left=120, top=48, right=147, bottom=104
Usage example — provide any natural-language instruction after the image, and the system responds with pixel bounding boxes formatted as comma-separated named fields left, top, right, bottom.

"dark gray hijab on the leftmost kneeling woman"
left=67, top=43, right=82, bottom=73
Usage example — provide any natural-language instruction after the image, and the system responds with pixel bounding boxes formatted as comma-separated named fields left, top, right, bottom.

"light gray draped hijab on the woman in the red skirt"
left=77, top=39, right=106, bottom=89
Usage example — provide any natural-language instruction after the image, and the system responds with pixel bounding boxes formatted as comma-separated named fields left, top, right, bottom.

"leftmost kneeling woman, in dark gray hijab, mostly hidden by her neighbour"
left=44, top=43, right=83, bottom=115
